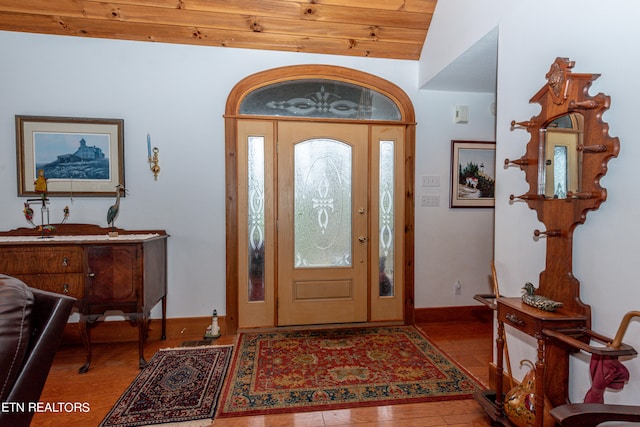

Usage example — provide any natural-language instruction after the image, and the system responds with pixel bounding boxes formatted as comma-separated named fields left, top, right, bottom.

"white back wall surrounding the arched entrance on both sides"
left=0, top=32, right=493, bottom=328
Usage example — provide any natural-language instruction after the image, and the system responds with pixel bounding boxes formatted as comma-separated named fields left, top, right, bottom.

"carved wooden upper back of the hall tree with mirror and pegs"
left=505, top=58, right=620, bottom=318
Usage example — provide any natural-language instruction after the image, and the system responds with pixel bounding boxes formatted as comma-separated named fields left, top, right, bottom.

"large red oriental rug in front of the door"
left=218, top=326, right=484, bottom=418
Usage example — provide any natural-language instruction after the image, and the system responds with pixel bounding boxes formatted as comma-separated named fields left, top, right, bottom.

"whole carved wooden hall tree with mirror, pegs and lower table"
left=476, top=58, right=635, bottom=427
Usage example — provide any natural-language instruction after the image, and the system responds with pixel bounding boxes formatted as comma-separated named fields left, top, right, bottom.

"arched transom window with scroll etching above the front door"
left=240, top=79, right=402, bottom=120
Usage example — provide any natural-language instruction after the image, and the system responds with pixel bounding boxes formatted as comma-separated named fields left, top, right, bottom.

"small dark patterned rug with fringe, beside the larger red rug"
left=100, top=346, right=233, bottom=427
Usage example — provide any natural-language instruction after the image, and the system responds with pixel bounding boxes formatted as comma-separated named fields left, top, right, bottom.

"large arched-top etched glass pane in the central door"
left=294, top=139, right=352, bottom=268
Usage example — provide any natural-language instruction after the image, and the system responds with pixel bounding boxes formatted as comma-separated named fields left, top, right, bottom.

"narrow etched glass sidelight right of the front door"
left=378, top=141, right=395, bottom=296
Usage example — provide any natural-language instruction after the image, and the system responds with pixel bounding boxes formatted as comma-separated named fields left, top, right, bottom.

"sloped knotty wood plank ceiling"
left=0, top=0, right=437, bottom=60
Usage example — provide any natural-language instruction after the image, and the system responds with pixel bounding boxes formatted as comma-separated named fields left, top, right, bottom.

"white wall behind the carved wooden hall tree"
left=422, top=0, right=640, bottom=404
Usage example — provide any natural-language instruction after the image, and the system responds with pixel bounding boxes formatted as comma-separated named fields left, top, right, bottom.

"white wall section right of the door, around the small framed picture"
left=415, top=91, right=495, bottom=307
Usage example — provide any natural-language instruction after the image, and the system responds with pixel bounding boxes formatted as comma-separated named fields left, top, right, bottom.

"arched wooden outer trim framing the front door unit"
left=224, top=65, right=415, bottom=333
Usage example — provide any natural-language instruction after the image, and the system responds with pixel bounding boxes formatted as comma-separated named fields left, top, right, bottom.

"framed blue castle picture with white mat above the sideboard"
left=16, top=116, right=124, bottom=197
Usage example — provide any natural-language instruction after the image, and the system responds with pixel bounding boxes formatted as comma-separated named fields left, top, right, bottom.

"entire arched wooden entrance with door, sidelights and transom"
left=225, top=65, right=415, bottom=332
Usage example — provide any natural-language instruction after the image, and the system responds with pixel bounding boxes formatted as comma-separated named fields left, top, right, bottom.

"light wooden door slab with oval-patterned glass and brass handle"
left=278, top=122, right=368, bottom=326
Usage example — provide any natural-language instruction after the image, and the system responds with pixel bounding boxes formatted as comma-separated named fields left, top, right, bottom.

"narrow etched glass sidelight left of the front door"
left=247, top=136, right=265, bottom=301
